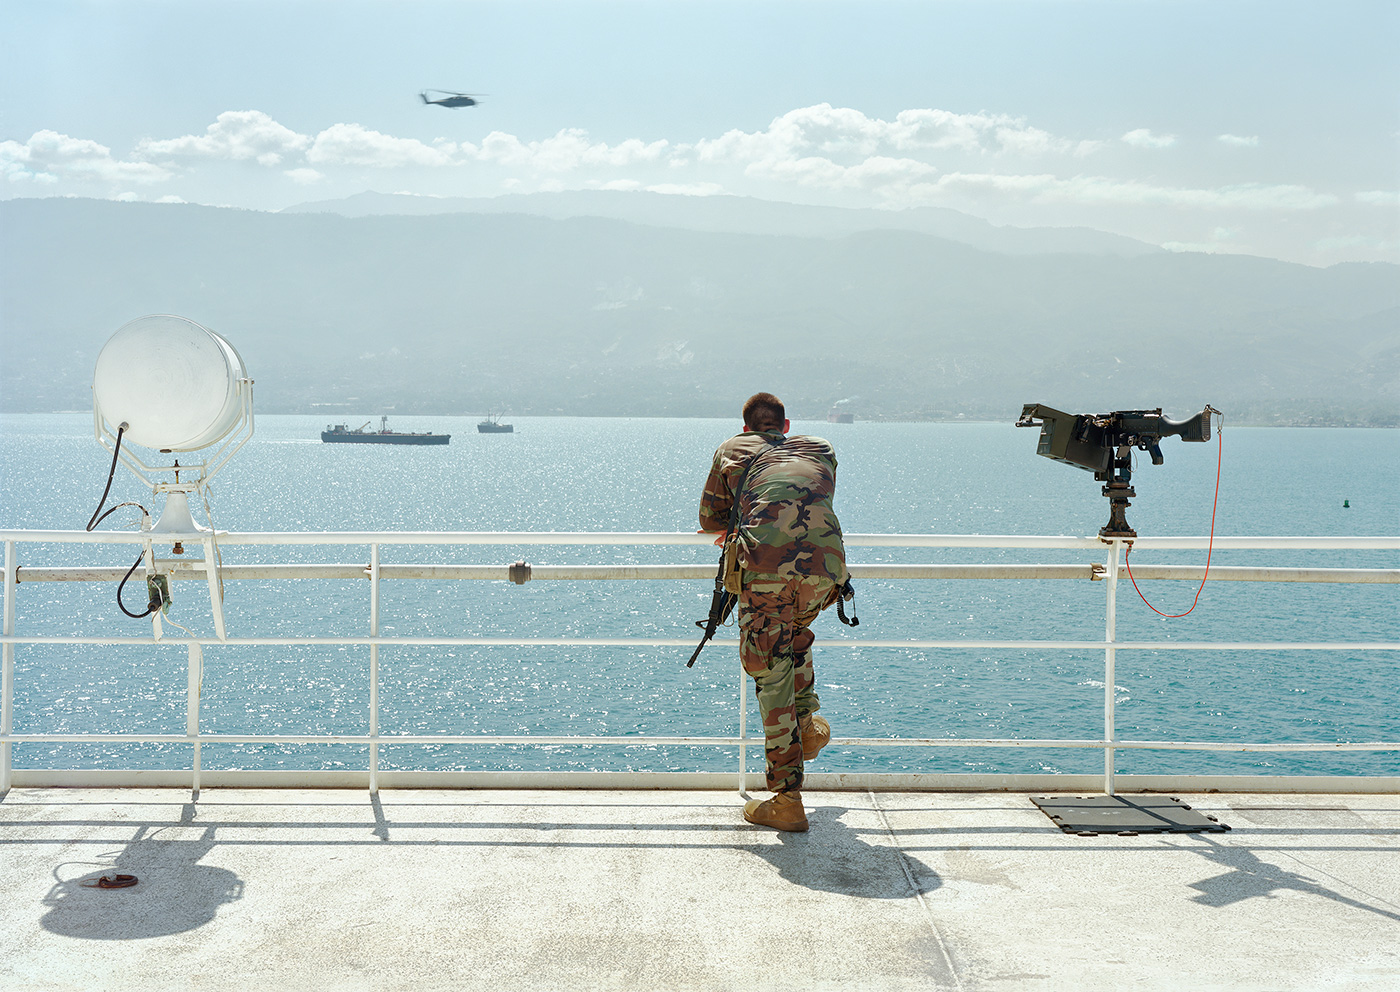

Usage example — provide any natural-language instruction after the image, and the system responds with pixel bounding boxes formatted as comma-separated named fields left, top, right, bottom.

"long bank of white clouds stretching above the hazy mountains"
left=0, top=104, right=1372, bottom=267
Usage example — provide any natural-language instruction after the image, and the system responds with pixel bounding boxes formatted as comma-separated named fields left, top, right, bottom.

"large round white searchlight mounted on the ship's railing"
left=92, top=313, right=253, bottom=533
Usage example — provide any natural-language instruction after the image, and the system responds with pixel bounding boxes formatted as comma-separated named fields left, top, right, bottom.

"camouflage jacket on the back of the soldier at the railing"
left=700, top=431, right=847, bottom=585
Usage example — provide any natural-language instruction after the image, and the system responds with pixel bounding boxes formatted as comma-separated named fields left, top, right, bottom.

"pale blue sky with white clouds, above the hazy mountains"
left=0, top=0, right=1400, bottom=266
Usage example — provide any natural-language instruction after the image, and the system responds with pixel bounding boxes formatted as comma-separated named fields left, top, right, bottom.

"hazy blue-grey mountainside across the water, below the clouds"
left=0, top=199, right=1400, bottom=424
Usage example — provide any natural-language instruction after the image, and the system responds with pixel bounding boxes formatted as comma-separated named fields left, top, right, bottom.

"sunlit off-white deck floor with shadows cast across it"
left=0, top=789, right=1400, bottom=992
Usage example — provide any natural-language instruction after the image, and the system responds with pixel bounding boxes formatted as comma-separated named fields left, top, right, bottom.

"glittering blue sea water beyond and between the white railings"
left=0, top=414, right=1400, bottom=775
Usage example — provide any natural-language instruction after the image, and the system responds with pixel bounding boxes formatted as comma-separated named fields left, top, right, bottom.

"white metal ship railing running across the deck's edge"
left=0, top=530, right=1400, bottom=795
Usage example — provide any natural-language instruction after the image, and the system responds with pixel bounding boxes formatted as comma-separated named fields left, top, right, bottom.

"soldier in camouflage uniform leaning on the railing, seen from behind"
left=700, top=393, right=847, bottom=831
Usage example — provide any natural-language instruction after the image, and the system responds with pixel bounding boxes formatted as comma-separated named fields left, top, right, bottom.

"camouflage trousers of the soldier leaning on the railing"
left=739, top=572, right=836, bottom=792
